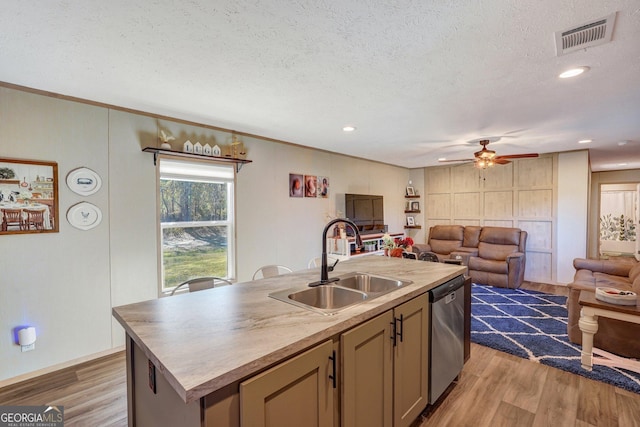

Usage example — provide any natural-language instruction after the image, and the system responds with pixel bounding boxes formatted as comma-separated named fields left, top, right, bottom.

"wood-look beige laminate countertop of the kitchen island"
left=113, top=256, right=465, bottom=403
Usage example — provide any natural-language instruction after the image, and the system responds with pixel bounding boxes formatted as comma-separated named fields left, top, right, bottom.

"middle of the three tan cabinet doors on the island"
left=340, top=311, right=393, bottom=427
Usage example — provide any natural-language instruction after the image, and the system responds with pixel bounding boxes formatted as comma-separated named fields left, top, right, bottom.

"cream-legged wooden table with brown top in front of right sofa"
left=578, top=291, right=640, bottom=373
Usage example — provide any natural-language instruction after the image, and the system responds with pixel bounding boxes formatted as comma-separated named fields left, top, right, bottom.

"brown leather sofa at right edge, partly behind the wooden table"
left=567, top=258, right=640, bottom=358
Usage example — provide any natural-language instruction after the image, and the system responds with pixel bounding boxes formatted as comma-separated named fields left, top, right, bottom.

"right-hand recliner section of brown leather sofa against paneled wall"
left=469, top=227, right=527, bottom=288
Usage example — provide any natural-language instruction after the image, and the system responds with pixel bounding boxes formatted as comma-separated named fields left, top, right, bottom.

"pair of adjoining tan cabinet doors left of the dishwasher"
left=340, top=294, right=429, bottom=427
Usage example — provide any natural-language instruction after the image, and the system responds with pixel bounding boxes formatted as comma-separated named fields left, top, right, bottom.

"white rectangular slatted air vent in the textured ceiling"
left=555, top=12, right=616, bottom=56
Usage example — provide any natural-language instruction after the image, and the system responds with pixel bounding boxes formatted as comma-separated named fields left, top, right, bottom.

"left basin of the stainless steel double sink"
left=269, top=285, right=368, bottom=314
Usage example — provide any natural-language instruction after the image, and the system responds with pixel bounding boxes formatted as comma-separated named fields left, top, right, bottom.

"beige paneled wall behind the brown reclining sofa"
left=425, top=155, right=557, bottom=283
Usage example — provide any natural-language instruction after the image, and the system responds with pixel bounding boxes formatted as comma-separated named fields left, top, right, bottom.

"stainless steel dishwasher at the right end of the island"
left=429, top=276, right=464, bottom=404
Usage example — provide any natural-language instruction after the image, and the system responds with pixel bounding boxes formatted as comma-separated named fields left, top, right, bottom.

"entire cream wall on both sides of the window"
left=0, top=87, right=410, bottom=380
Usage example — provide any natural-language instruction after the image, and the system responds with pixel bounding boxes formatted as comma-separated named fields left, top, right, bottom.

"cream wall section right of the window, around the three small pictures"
left=237, top=138, right=409, bottom=280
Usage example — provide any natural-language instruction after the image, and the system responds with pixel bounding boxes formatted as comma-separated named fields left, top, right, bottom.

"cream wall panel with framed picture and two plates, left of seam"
left=0, top=88, right=111, bottom=379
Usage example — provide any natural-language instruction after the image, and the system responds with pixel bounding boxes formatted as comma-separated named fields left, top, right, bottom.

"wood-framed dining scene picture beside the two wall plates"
left=0, top=158, right=59, bottom=234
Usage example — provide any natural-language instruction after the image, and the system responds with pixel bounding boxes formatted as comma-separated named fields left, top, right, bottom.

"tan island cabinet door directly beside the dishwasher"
left=393, top=294, right=429, bottom=427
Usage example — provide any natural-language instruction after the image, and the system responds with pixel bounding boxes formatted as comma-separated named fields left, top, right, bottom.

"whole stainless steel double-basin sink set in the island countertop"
left=269, top=273, right=413, bottom=315
